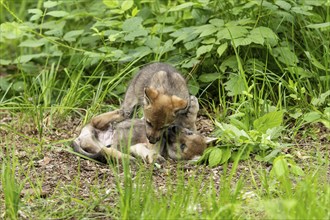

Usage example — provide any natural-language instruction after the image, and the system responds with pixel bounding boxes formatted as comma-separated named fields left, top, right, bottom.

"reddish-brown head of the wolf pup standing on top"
left=144, top=88, right=188, bottom=144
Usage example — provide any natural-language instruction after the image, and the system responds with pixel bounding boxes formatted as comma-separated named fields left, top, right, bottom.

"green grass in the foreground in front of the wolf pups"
left=1, top=136, right=330, bottom=219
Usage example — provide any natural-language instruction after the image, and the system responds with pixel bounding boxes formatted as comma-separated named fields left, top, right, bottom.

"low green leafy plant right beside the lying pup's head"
left=199, top=111, right=285, bottom=166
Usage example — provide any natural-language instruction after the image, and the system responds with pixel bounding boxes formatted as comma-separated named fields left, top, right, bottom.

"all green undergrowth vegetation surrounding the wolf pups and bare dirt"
left=0, top=0, right=330, bottom=219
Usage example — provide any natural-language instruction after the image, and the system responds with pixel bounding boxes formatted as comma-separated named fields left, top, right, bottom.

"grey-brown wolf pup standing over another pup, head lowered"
left=91, top=63, right=197, bottom=144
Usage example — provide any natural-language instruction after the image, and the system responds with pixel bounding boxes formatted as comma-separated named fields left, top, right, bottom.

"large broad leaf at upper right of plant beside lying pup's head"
left=253, top=111, right=283, bottom=134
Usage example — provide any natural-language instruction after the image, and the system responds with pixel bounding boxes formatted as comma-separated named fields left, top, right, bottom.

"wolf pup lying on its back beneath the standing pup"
left=72, top=97, right=212, bottom=163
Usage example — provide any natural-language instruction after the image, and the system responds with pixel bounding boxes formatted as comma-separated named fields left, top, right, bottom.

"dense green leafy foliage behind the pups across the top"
left=0, top=0, right=330, bottom=106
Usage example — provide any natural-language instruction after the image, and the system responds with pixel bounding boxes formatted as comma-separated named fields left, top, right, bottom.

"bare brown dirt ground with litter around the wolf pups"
left=0, top=112, right=330, bottom=213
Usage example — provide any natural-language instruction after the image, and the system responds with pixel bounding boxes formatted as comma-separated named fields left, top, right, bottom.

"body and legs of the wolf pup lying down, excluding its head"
left=72, top=110, right=158, bottom=163
